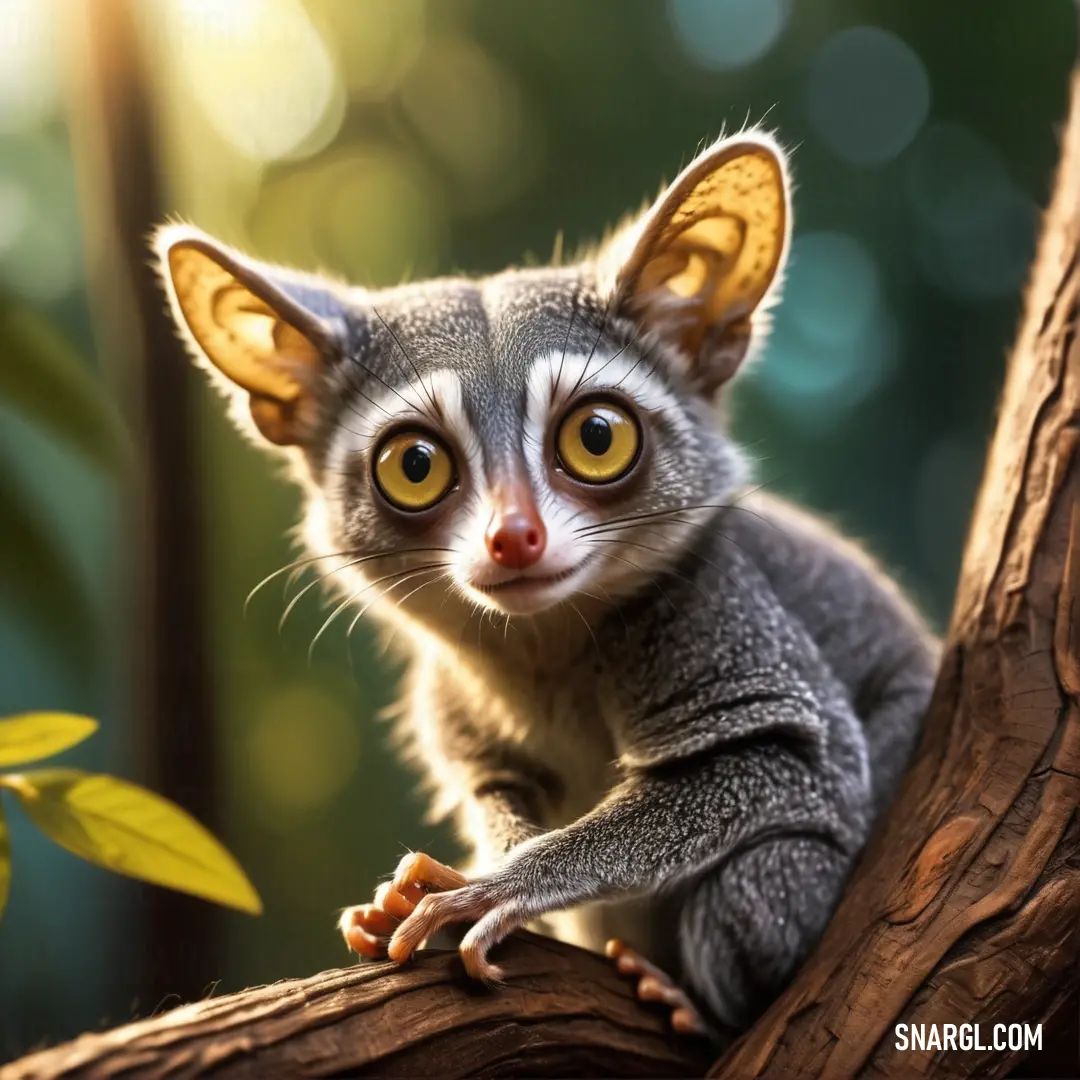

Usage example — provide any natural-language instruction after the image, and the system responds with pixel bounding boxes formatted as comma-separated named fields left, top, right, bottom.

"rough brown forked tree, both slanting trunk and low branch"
left=0, top=29, right=1080, bottom=1080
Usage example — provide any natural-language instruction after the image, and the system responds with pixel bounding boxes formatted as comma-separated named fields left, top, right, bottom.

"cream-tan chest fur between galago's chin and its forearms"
left=395, top=598, right=622, bottom=820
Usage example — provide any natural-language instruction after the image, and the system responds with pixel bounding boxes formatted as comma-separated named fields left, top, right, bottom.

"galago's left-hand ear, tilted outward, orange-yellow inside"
left=153, top=225, right=341, bottom=446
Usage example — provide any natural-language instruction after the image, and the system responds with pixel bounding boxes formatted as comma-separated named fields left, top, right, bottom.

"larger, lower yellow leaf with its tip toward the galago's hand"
left=5, top=769, right=262, bottom=915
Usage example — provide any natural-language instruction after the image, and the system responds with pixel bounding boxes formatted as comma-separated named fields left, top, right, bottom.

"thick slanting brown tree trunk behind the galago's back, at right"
left=712, top=67, right=1080, bottom=1080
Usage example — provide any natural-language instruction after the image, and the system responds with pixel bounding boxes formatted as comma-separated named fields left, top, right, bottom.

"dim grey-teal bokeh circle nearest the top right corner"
left=807, top=26, right=930, bottom=165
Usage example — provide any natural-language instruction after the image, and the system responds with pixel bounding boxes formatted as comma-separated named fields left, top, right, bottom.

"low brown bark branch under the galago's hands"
left=0, top=934, right=712, bottom=1080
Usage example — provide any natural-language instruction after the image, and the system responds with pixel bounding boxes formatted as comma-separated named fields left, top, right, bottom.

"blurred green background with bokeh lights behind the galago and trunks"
left=0, top=0, right=1077, bottom=1058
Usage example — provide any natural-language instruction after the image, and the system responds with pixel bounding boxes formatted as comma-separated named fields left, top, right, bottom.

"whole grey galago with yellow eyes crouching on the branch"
left=158, top=133, right=936, bottom=1030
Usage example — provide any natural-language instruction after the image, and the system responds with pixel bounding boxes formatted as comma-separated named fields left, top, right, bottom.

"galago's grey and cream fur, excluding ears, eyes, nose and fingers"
left=156, top=132, right=937, bottom=1029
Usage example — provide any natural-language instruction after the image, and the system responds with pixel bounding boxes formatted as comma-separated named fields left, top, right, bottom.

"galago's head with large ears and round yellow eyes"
left=154, top=132, right=791, bottom=619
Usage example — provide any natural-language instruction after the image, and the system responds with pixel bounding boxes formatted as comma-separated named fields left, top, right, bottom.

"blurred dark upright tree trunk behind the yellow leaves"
left=64, top=0, right=220, bottom=1009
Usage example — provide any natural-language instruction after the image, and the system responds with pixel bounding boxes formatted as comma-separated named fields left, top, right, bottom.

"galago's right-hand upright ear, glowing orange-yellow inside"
left=599, top=132, right=791, bottom=394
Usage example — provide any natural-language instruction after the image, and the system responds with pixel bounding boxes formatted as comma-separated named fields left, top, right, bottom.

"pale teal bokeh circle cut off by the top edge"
left=667, top=0, right=791, bottom=70
